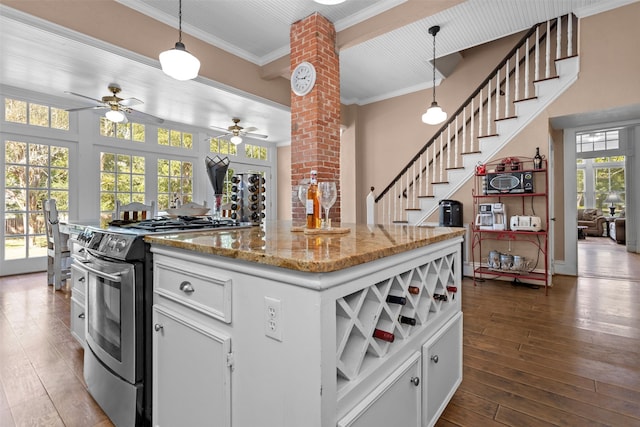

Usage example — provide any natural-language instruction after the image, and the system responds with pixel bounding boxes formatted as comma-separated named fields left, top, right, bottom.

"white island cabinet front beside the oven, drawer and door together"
left=152, top=257, right=232, bottom=427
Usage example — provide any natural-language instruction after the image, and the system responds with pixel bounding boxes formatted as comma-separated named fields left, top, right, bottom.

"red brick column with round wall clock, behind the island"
left=290, top=13, right=340, bottom=224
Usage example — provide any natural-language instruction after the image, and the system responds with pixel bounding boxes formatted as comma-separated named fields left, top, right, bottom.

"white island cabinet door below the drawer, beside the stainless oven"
left=152, top=305, right=231, bottom=427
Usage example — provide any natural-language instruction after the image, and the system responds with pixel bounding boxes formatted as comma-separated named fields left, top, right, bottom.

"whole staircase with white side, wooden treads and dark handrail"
left=376, top=15, right=580, bottom=225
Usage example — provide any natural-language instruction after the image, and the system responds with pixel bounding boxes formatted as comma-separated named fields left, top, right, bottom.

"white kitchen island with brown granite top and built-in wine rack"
left=145, top=221, right=464, bottom=427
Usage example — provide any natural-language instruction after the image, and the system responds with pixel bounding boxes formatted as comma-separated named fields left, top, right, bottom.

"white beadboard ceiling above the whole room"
left=0, top=0, right=637, bottom=143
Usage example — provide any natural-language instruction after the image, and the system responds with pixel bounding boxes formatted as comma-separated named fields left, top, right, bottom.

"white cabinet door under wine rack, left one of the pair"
left=338, top=352, right=422, bottom=427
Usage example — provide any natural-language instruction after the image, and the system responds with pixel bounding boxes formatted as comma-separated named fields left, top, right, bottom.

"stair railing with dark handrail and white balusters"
left=375, top=15, right=577, bottom=224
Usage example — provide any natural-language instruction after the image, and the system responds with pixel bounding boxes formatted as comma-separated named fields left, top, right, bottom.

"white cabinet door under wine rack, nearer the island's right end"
left=422, top=313, right=462, bottom=426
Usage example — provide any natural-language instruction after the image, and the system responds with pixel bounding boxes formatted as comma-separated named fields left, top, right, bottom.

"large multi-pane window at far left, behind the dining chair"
left=4, top=141, right=69, bottom=260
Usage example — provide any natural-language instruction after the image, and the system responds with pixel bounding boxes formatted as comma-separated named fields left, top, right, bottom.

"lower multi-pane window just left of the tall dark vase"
left=158, top=159, right=193, bottom=210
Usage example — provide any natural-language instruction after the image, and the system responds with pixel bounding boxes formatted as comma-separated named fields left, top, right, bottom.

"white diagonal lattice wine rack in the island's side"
left=336, top=254, right=455, bottom=387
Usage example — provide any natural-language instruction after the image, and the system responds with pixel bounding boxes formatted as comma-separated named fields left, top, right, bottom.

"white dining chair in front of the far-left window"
left=42, top=199, right=71, bottom=291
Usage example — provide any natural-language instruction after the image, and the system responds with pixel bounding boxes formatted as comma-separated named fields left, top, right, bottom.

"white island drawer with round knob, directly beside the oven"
left=153, top=259, right=231, bottom=323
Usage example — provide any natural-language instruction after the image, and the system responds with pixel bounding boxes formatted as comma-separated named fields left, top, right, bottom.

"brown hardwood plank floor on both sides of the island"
left=0, top=238, right=640, bottom=427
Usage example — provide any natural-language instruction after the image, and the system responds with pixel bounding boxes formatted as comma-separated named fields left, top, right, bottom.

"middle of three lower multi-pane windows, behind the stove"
left=100, top=153, right=145, bottom=226
